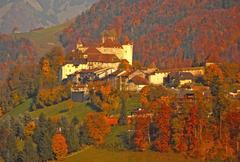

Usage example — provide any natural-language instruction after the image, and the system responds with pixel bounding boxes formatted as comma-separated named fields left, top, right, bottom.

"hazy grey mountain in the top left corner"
left=0, top=0, right=97, bottom=33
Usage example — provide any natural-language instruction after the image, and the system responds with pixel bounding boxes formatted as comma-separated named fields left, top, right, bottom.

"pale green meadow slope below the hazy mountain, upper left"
left=16, top=22, right=70, bottom=55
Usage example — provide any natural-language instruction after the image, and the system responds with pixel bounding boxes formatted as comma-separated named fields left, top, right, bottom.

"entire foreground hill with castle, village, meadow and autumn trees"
left=0, top=31, right=240, bottom=162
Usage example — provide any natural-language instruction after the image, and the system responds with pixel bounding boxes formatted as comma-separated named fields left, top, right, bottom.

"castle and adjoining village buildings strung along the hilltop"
left=58, top=36, right=220, bottom=101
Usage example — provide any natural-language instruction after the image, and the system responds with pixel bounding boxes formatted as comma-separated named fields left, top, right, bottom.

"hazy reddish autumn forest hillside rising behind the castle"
left=61, top=0, right=240, bottom=68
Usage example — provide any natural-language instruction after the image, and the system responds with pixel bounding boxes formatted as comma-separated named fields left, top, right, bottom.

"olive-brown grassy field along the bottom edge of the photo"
left=61, top=148, right=201, bottom=162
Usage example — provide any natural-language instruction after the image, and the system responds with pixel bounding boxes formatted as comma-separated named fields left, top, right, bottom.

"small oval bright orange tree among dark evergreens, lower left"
left=52, top=133, right=68, bottom=160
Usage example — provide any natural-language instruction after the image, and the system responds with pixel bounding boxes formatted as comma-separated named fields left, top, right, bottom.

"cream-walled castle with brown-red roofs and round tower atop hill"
left=59, top=36, right=133, bottom=80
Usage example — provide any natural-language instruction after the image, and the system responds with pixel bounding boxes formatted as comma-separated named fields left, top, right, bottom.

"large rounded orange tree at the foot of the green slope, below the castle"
left=85, top=112, right=110, bottom=144
